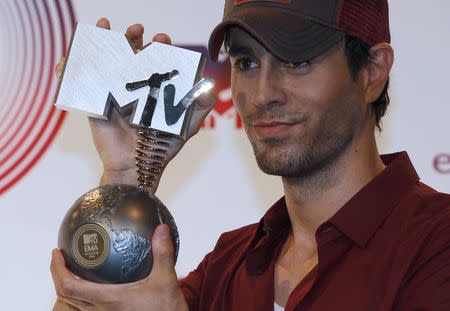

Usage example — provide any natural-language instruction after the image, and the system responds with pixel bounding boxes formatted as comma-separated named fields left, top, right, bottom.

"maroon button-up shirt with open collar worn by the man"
left=180, top=152, right=450, bottom=311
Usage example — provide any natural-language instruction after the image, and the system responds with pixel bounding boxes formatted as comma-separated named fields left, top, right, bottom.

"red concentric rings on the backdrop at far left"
left=0, top=0, right=75, bottom=194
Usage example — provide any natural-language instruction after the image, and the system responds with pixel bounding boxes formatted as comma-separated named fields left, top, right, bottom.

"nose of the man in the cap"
left=252, top=64, right=286, bottom=109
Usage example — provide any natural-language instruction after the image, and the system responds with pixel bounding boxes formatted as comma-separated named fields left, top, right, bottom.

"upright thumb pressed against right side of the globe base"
left=150, top=224, right=177, bottom=282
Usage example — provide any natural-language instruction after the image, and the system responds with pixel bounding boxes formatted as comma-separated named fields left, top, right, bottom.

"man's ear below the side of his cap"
left=364, top=43, right=394, bottom=103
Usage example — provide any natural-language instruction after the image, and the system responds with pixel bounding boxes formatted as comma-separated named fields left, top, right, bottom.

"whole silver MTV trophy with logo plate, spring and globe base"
left=55, top=24, right=214, bottom=283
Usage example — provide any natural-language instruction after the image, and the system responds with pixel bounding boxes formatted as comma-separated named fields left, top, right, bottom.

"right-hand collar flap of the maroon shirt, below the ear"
left=328, top=152, right=419, bottom=247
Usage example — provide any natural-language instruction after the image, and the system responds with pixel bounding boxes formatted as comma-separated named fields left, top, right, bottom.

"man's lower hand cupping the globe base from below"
left=50, top=225, right=188, bottom=311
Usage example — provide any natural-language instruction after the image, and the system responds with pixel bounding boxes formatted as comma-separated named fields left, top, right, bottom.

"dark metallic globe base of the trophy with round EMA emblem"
left=58, top=185, right=179, bottom=283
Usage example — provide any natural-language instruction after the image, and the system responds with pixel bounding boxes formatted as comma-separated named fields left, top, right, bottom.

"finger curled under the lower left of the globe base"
left=50, top=250, right=120, bottom=304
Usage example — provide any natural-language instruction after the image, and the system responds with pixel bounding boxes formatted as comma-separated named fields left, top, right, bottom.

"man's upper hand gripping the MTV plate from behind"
left=56, top=18, right=215, bottom=192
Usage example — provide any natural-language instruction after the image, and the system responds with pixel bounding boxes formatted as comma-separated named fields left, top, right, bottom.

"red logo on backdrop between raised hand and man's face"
left=183, top=45, right=242, bottom=128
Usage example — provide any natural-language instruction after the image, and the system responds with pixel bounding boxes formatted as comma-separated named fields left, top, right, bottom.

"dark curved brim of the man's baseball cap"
left=208, top=7, right=345, bottom=63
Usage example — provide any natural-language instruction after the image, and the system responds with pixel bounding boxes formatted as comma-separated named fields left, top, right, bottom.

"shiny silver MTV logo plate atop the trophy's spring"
left=55, top=24, right=214, bottom=136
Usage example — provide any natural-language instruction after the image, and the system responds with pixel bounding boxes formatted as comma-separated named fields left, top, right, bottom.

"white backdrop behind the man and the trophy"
left=0, top=0, right=450, bottom=310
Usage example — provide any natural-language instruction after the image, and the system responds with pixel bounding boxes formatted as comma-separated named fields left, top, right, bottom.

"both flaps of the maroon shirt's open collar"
left=246, top=152, right=419, bottom=274
